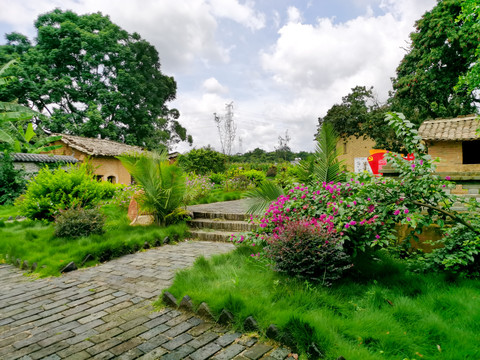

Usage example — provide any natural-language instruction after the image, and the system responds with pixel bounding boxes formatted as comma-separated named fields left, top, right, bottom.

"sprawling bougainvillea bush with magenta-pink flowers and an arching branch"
left=232, top=114, right=480, bottom=278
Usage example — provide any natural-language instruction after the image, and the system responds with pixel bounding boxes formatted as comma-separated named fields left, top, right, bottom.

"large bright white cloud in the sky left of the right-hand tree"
left=255, top=0, right=435, bottom=149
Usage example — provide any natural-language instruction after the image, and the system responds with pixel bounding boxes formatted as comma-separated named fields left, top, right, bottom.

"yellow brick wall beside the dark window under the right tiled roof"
left=428, top=141, right=480, bottom=174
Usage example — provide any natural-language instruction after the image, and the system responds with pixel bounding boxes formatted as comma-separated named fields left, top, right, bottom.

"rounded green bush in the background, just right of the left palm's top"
left=178, top=147, right=226, bottom=175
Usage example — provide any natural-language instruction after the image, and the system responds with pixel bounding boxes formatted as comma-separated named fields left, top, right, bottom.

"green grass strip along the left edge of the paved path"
left=0, top=205, right=187, bottom=277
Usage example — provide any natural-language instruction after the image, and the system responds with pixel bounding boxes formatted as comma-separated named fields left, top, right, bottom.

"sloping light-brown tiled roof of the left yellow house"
left=52, top=134, right=143, bottom=156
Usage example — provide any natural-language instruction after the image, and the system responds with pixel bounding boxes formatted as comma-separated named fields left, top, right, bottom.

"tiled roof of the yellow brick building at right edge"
left=418, top=115, right=480, bottom=141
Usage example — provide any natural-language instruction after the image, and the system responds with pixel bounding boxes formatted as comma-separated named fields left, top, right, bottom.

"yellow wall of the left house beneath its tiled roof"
left=53, top=141, right=131, bottom=185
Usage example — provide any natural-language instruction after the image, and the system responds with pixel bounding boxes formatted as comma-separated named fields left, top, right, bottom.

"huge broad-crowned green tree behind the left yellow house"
left=0, top=9, right=191, bottom=149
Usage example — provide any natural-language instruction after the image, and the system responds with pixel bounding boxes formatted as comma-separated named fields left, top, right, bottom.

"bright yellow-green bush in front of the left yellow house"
left=16, top=164, right=114, bottom=221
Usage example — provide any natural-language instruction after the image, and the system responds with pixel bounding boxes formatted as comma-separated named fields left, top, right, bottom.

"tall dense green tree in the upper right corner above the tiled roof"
left=392, top=0, right=480, bottom=125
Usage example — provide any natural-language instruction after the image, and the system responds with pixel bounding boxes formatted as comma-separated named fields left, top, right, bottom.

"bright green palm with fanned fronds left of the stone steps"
left=117, top=152, right=186, bottom=226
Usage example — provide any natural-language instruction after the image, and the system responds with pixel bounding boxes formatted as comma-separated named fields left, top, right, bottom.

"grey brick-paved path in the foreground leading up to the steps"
left=0, top=241, right=288, bottom=360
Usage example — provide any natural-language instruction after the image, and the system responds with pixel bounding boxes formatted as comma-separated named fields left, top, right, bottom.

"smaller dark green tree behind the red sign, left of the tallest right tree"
left=318, top=86, right=402, bottom=151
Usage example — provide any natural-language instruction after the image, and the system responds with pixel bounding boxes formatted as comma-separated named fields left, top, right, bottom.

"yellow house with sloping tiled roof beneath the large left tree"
left=52, top=134, right=143, bottom=185
